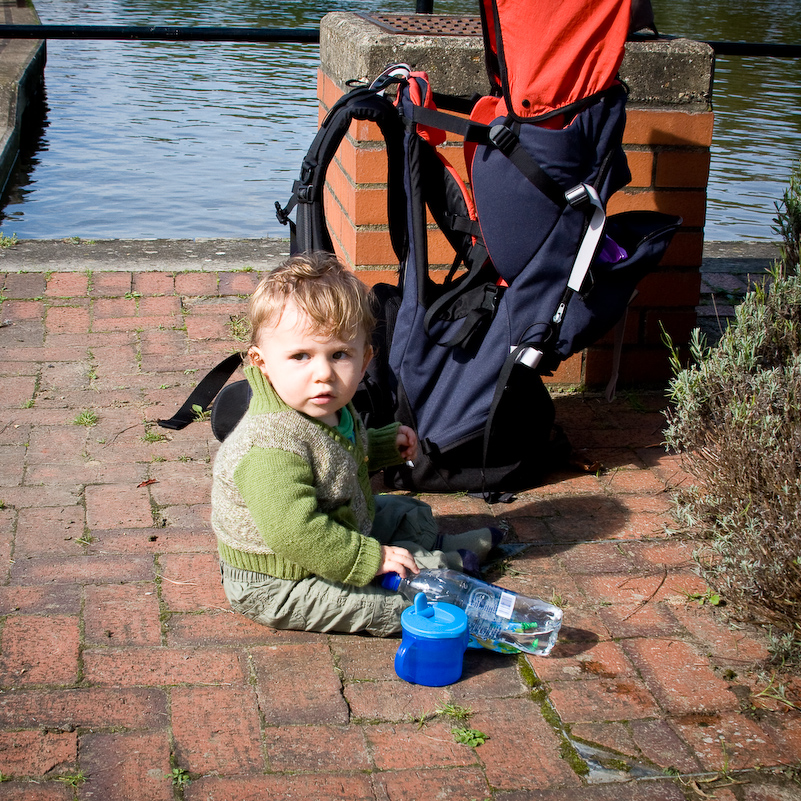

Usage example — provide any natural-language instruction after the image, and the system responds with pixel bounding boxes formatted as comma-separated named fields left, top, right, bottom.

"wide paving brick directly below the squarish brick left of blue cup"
left=264, top=725, right=372, bottom=772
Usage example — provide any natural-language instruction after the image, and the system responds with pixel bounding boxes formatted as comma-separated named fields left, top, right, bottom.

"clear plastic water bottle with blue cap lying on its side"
left=381, top=570, right=562, bottom=656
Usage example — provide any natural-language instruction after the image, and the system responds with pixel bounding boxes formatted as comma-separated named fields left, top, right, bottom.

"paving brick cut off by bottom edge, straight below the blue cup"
left=374, top=768, right=490, bottom=801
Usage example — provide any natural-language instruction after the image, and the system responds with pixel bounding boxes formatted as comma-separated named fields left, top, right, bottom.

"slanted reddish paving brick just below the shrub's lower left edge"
left=623, top=639, right=739, bottom=715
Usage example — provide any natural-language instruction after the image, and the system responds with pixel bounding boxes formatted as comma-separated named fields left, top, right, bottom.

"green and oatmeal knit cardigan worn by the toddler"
left=211, top=366, right=402, bottom=586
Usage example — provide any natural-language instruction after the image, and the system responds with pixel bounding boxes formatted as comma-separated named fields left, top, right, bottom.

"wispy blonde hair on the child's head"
left=248, top=253, right=375, bottom=345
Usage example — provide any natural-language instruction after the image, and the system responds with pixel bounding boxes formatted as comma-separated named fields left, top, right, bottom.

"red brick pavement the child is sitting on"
left=0, top=255, right=801, bottom=801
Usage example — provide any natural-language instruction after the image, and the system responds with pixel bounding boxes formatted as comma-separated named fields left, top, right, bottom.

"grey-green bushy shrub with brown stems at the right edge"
left=666, top=165, right=801, bottom=639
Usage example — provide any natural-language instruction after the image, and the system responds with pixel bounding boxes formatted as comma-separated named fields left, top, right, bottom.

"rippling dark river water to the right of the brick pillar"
left=652, top=0, right=801, bottom=240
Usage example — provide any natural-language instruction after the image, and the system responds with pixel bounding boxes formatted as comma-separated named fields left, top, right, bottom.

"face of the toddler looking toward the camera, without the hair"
left=248, top=301, right=372, bottom=426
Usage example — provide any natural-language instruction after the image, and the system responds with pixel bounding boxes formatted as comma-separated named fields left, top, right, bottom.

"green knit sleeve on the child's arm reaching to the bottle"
left=234, top=448, right=381, bottom=587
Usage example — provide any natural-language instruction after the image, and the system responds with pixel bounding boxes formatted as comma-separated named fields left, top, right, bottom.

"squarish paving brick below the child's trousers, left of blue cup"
left=251, top=642, right=349, bottom=725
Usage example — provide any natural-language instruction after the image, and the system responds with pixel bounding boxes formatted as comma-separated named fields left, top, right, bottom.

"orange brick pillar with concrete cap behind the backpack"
left=318, top=13, right=713, bottom=386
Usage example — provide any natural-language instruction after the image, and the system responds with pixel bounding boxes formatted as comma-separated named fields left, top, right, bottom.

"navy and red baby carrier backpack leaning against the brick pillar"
left=163, top=0, right=681, bottom=495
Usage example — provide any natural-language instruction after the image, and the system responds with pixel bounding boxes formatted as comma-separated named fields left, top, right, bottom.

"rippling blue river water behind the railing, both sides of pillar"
left=0, top=0, right=801, bottom=240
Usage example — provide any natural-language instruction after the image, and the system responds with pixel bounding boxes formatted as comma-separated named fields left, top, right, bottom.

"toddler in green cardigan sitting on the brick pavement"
left=212, top=254, right=502, bottom=636
